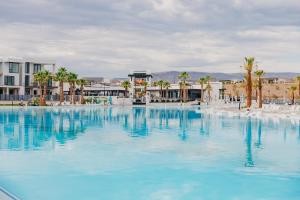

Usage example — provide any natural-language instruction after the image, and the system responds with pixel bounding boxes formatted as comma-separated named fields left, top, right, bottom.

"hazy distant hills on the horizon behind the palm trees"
left=152, top=71, right=300, bottom=83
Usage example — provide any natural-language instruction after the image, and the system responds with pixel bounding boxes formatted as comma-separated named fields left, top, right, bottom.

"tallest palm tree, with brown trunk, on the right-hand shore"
left=244, top=57, right=255, bottom=108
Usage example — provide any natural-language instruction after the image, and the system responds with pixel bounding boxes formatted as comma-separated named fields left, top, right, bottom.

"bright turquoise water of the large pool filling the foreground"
left=0, top=107, right=300, bottom=200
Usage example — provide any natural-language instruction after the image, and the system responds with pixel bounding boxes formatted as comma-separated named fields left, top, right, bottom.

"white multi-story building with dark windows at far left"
left=0, top=58, right=55, bottom=95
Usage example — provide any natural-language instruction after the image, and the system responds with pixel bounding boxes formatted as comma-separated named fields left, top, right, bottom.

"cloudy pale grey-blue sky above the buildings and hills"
left=0, top=0, right=300, bottom=77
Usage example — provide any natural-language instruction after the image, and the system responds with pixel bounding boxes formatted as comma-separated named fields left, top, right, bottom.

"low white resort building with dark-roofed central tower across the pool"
left=69, top=71, right=224, bottom=104
